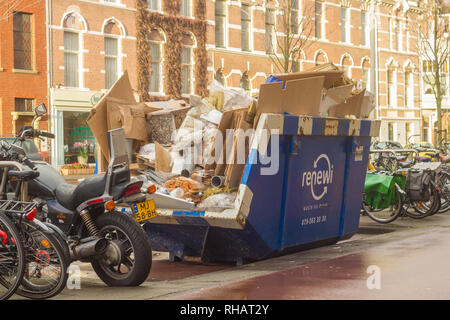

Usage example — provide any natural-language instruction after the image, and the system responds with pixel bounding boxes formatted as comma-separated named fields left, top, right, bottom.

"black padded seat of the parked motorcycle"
left=55, top=174, right=106, bottom=210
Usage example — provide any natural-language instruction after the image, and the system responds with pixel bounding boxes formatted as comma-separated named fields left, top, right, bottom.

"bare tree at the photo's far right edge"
left=417, top=0, right=450, bottom=143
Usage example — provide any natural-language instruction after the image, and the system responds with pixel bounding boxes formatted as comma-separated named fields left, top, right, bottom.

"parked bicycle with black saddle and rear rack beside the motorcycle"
left=0, top=141, right=70, bottom=299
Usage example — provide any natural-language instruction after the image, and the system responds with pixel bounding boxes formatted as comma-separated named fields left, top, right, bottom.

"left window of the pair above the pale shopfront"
left=64, top=31, right=79, bottom=87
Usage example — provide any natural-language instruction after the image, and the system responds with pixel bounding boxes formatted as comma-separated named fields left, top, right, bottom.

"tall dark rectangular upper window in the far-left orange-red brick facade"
left=13, top=12, right=33, bottom=70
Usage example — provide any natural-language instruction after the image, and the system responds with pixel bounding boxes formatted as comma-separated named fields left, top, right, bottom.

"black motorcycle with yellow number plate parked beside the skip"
left=5, top=104, right=152, bottom=286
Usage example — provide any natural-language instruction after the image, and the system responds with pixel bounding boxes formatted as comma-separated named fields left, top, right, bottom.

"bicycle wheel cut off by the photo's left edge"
left=0, top=214, right=25, bottom=300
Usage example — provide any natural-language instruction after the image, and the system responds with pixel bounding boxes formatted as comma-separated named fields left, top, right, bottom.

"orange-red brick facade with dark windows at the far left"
left=0, top=0, right=48, bottom=136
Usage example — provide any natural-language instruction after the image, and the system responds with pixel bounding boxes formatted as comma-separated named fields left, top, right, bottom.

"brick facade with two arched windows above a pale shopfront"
left=47, top=0, right=136, bottom=165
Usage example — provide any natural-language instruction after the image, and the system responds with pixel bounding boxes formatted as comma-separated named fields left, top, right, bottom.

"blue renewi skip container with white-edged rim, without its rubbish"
left=145, top=114, right=380, bottom=263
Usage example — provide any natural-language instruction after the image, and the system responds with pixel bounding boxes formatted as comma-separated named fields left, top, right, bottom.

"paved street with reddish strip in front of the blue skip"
left=22, top=213, right=450, bottom=300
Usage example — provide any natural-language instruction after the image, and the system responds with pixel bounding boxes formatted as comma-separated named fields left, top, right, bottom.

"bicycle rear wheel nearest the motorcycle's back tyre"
left=16, top=221, right=69, bottom=299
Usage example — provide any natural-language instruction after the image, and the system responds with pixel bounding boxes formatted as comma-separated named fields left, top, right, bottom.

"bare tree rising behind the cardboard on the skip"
left=266, top=0, right=314, bottom=73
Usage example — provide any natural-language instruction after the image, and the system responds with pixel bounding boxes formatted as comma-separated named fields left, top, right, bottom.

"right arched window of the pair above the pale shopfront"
left=103, top=20, right=122, bottom=89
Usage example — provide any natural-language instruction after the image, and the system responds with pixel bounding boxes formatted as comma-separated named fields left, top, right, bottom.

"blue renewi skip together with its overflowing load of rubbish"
left=89, top=66, right=380, bottom=263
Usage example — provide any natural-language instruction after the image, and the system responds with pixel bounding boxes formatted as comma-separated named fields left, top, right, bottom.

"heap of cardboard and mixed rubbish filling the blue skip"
left=88, top=65, right=373, bottom=209
